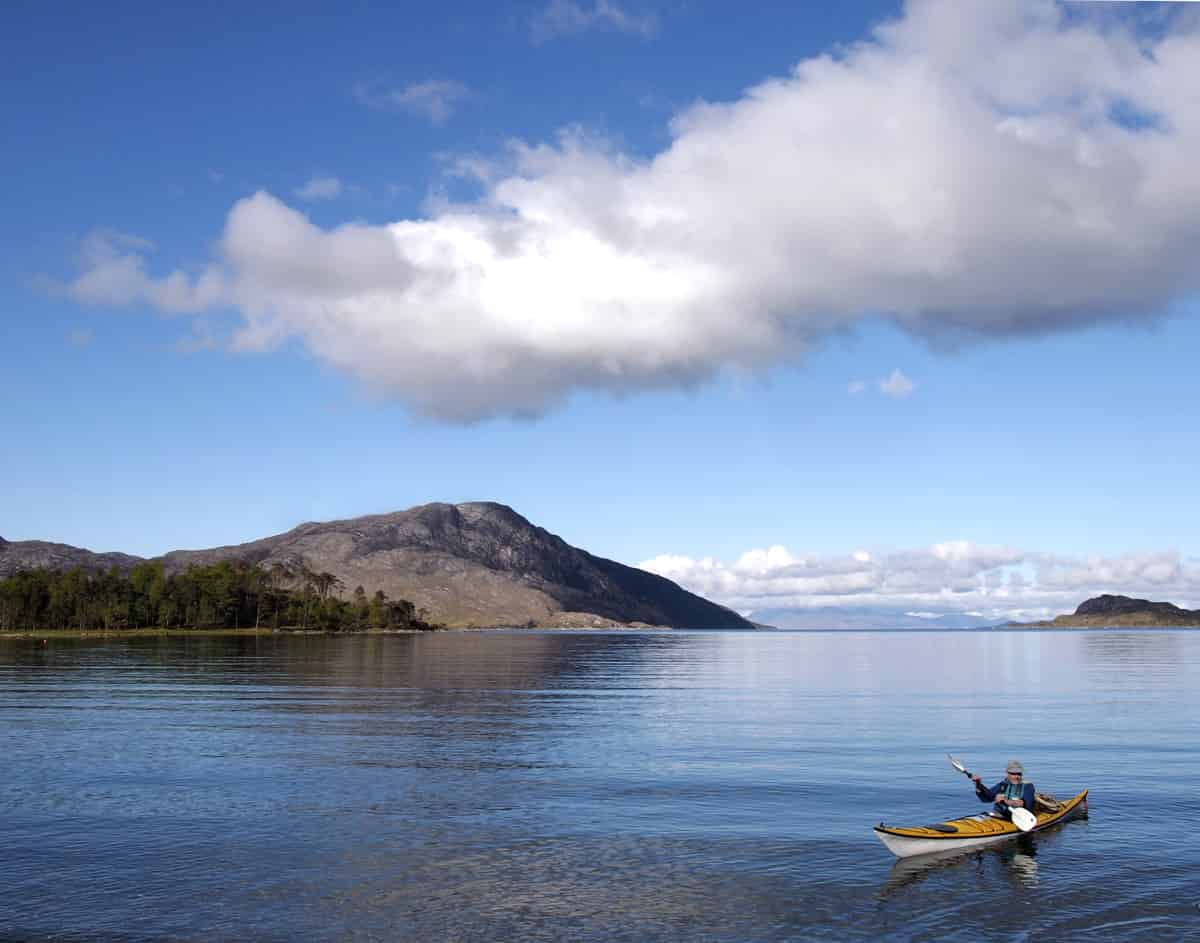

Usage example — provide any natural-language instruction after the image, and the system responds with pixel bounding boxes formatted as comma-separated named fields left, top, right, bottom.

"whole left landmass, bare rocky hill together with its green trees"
left=0, top=501, right=760, bottom=632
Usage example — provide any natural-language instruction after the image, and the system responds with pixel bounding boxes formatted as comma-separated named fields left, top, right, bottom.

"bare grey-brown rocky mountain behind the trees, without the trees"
left=0, top=501, right=755, bottom=629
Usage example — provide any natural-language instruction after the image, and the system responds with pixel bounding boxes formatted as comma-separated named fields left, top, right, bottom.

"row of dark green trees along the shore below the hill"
left=0, top=560, right=437, bottom=632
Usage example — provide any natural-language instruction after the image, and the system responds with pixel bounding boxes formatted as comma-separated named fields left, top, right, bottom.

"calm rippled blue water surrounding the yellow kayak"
left=0, top=631, right=1200, bottom=942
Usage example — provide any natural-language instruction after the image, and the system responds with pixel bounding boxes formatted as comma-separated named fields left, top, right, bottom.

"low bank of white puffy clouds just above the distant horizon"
left=640, top=541, right=1200, bottom=619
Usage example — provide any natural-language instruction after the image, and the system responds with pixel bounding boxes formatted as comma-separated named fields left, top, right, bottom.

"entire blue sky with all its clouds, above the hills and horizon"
left=0, top=0, right=1200, bottom=613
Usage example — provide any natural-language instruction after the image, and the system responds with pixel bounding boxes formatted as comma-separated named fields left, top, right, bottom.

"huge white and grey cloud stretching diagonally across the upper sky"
left=71, top=0, right=1200, bottom=420
